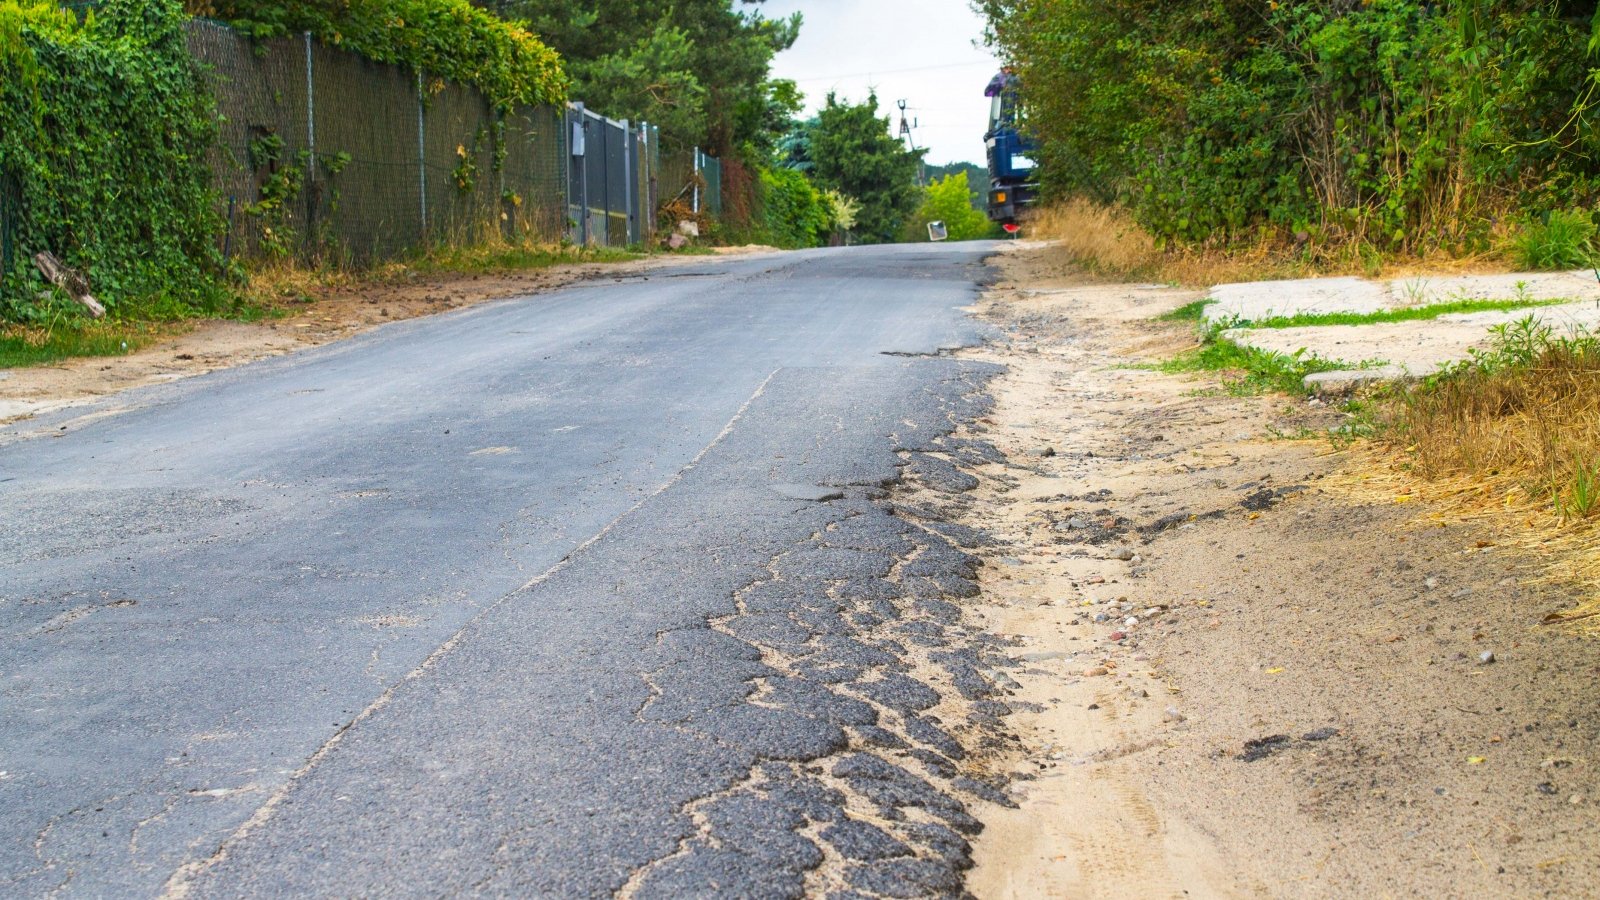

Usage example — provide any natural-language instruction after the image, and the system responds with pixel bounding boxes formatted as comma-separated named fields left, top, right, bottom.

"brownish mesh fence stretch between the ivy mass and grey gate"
left=187, top=21, right=566, bottom=263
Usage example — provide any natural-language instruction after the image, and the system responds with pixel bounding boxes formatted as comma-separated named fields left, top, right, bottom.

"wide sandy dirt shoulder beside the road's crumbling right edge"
left=968, top=243, right=1600, bottom=898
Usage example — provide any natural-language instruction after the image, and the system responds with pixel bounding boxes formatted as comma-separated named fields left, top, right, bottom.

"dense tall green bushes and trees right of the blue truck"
left=979, top=0, right=1600, bottom=267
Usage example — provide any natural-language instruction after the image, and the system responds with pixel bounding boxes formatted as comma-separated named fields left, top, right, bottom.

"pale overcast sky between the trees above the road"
left=760, top=0, right=1000, bottom=165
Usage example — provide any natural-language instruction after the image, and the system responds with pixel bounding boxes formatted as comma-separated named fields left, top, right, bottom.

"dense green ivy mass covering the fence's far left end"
left=0, top=0, right=222, bottom=322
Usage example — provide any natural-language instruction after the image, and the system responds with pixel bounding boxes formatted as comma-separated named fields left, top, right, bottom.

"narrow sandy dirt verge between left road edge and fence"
left=0, top=247, right=745, bottom=424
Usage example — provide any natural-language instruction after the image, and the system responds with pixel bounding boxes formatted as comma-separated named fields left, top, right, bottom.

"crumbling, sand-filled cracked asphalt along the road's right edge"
left=618, top=364, right=1018, bottom=900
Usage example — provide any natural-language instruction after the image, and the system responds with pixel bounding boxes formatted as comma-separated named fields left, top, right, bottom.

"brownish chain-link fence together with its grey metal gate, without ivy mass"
left=0, top=19, right=720, bottom=294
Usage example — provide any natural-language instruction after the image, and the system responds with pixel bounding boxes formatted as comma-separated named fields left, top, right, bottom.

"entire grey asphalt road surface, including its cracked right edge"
left=0, top=245, right=1005, bottom=897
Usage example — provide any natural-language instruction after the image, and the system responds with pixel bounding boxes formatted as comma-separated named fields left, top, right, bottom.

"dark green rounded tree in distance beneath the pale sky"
left=808, top=93, right=925, bottom=243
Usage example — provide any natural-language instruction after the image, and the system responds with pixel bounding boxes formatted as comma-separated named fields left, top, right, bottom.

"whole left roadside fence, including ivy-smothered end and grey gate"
left=0, top=0, right=715, bottom=322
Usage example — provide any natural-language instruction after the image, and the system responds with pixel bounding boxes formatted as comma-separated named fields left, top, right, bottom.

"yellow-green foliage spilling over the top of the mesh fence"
left=216, top=0, right=566, bottom=107
